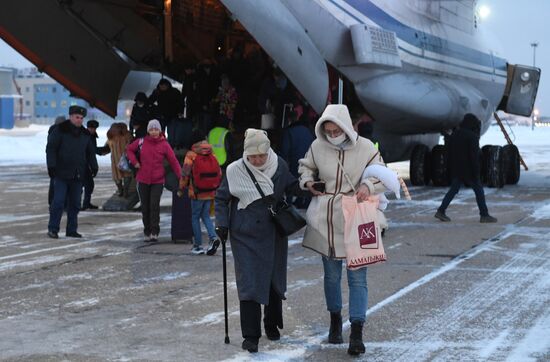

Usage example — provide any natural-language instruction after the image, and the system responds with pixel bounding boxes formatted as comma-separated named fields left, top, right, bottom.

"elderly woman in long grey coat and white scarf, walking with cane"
left=216, top=129, right=299, bottom=352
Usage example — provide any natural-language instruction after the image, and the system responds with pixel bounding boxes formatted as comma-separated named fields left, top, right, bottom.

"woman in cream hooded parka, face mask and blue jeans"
left=298, top=104, right=385, bottom=355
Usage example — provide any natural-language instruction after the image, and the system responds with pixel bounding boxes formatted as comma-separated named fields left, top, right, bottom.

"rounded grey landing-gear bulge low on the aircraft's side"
left=355, top=72, right=495, bottom=135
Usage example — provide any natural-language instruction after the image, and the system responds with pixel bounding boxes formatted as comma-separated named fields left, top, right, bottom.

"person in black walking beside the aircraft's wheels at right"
left=434, top=113, right=497, bottom=223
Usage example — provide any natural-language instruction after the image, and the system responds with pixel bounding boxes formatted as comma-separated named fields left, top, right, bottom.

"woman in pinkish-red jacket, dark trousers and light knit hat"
left=126, top=119, right=181, bottom=243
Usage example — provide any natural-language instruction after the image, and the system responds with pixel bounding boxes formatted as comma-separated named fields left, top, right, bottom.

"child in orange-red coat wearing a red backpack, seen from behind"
left=179, top=131, right=222, bottom=255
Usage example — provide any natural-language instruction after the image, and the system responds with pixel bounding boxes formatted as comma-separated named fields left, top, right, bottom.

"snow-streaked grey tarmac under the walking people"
left=0, top=148, right=550, bottom=361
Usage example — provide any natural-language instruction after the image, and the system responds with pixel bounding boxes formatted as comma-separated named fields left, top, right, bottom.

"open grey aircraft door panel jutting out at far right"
left=498, top=64, right=541, bottom=117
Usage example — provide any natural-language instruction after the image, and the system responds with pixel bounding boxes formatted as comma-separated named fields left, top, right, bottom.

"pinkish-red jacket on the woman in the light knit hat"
left=126, top=135, right=181, bottom=185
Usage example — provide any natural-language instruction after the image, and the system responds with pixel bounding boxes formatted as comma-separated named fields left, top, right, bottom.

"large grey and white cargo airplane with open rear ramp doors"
left=0, top=0, right=541, bottom=187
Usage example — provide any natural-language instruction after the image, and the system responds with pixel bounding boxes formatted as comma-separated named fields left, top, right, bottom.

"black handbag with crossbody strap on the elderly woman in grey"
left=243, top=161, right=306, bottom=236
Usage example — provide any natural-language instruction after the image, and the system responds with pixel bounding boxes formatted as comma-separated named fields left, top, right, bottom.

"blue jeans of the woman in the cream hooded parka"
left=323, top=256, right=368, bottom=322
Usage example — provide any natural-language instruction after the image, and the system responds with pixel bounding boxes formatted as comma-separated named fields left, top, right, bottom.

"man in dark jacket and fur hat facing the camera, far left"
left=46, top=106, right=98, bottom=239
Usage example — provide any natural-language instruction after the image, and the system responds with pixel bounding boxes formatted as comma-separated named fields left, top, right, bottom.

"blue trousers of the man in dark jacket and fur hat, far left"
left=48, top=177, right=82, bottom=233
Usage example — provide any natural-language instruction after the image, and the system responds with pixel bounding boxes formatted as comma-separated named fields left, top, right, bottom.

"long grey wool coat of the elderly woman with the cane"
left=215, top=157, right=299, bottom=305
